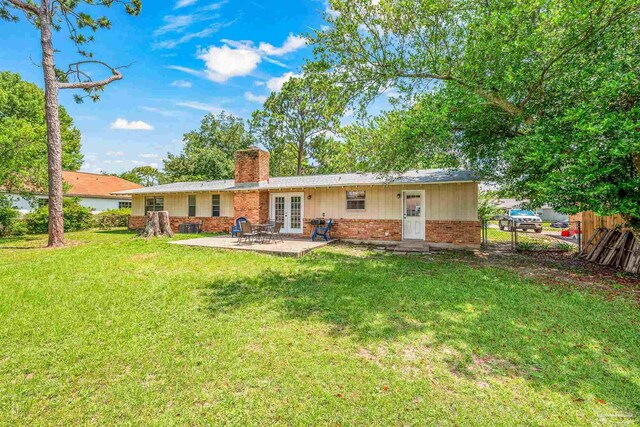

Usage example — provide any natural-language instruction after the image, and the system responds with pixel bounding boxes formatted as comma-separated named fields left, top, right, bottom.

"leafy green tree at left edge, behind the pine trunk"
left=0, top=72, right=82, bottom=194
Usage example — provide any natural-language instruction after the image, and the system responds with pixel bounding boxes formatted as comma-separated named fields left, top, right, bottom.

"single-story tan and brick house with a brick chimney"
left=116, top=147, right=480, bottom=247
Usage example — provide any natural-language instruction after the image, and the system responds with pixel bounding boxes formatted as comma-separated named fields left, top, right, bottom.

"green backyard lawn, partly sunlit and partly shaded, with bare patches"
left=0, top=231, right=640, bottom=426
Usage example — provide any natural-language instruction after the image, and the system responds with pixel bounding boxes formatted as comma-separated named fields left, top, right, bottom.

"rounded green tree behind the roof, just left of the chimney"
left=164, top=112, right=253, bottom=182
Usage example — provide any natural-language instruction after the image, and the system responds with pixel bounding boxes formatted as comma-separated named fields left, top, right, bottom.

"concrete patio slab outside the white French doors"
left=171, top=236, right=335, bottom=258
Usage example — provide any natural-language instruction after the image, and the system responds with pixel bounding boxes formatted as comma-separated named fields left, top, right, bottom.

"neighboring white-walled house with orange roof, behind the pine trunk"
left=9, top=171, right=142, bottom=213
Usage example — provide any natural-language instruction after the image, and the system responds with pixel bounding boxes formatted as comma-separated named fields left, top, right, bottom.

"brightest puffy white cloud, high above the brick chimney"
left=198, top=41, right=262, bottom=83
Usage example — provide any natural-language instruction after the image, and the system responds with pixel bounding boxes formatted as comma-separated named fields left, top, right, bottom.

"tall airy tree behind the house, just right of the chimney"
left=251, top=72, right=348, bottom=175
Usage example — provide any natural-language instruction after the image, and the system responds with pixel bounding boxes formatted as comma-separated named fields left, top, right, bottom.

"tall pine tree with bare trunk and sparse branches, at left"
left=0, top=0, right=142, bottom=247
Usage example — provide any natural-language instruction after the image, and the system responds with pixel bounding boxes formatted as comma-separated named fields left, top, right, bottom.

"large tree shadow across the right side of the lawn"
left=201, top=252, right=640, bottom=416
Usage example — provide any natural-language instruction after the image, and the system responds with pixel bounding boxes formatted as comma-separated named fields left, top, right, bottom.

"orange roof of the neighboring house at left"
left=62, top=171, right=142, bottom=199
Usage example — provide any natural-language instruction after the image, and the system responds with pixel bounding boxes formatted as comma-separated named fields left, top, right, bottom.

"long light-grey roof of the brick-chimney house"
left=115, top=169, right=478, bottom=195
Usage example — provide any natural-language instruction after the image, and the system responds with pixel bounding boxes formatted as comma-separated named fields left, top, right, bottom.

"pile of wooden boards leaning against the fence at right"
left=579, top=228, right=640, bottom=274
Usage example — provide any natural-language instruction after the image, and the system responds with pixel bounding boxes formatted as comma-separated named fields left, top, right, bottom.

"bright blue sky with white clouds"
left=0, top=0, right=325, bottom=172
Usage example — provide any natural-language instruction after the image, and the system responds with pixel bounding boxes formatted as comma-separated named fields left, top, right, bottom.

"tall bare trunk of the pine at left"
left=40, top=0, right=64, bottom=247
